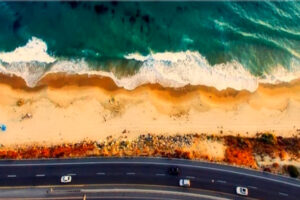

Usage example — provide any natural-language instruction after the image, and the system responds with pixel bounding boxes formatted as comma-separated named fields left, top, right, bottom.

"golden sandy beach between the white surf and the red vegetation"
left=0, top=74, right=300, bottom=146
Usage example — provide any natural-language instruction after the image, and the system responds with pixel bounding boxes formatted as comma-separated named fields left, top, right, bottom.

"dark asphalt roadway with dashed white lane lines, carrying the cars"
left=0, top=158, right=300, bottom=200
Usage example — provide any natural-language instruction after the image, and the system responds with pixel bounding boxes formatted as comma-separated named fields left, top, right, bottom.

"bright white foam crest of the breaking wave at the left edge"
left=0, top=37, right=55, bottom=63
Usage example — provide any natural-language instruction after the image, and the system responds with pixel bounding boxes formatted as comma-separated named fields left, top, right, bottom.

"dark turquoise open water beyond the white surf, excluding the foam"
left=0, top=1, right=300, bottom=90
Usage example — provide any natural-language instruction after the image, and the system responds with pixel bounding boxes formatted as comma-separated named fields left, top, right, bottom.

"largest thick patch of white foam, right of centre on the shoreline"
left=123, top=51, right=258, bottom=91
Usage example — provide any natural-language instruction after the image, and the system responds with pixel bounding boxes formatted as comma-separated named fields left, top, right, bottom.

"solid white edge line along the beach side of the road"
left=0, top=161, right=300, bottom=188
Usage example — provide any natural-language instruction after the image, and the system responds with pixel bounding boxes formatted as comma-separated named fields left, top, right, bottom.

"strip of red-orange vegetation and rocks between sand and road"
left=0, top=134, right=300, bottom=177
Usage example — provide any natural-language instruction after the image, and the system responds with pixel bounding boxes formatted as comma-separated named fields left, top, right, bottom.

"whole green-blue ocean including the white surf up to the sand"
left=0, top=1, right=300, bottom=92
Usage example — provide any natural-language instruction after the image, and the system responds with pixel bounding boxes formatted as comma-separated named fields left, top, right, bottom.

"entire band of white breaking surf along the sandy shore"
left=0, top=38, right=300, bottom=92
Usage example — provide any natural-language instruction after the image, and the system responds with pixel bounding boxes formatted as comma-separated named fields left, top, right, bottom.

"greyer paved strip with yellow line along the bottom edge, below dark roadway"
left=0, top=184, right=240, bottom=200
